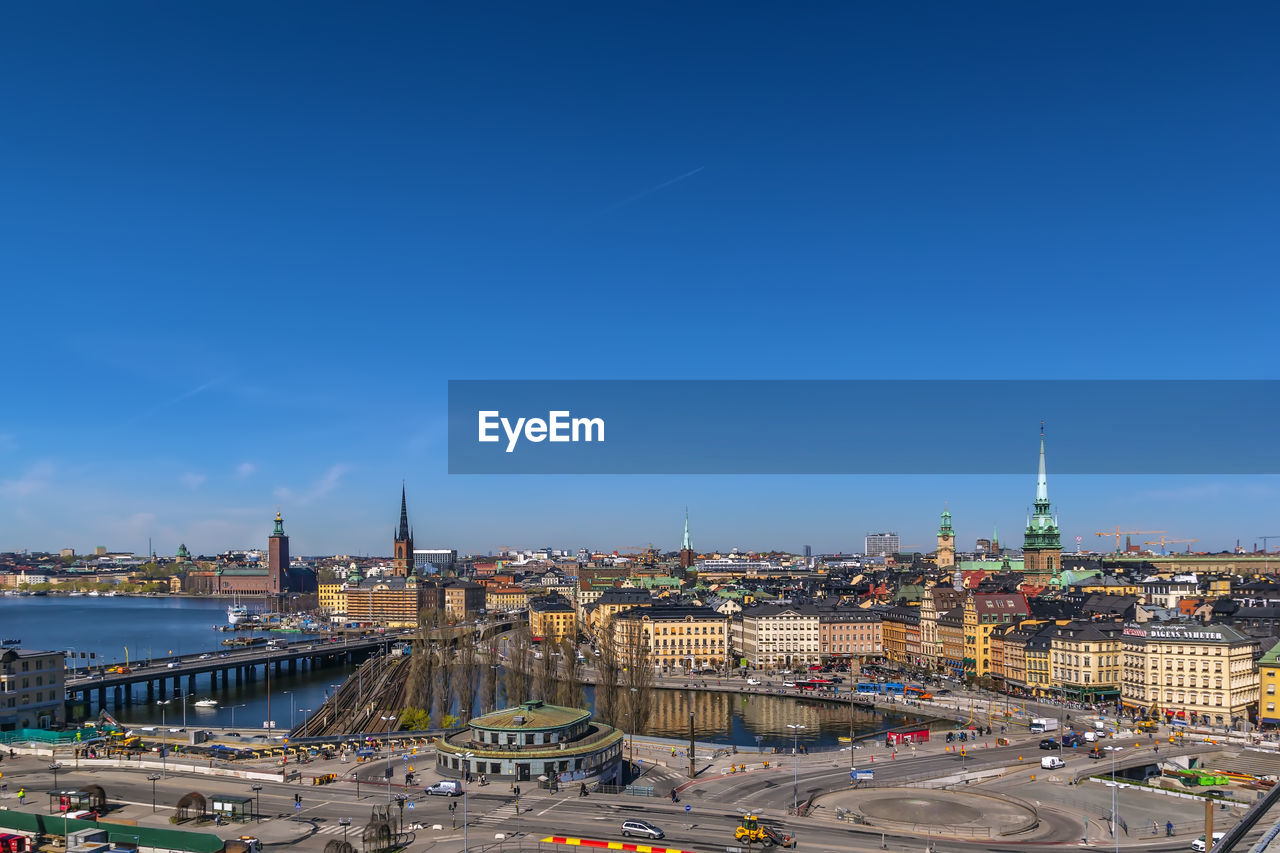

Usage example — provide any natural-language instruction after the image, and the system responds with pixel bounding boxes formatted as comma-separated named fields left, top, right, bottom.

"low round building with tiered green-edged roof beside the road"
left=435, top=701, right=622, bottom=785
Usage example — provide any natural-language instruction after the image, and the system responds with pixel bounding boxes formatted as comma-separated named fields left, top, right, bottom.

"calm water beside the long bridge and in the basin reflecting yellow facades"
left=0, top=596, right=909, bottom=745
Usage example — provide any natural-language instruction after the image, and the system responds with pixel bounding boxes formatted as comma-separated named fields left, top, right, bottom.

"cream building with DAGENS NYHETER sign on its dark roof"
left=1121, top=622, right=1254, bottom=726
